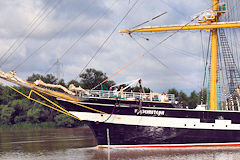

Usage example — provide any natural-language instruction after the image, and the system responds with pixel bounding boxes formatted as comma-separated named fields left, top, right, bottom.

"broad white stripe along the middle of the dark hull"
left=70, top=111, right=240, bottom=131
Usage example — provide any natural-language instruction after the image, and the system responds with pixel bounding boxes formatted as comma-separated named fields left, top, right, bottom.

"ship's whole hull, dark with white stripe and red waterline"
left=59, top=100, right=240, bottom=148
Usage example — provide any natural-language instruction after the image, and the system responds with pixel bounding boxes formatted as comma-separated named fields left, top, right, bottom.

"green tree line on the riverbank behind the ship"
left=0, top=68, right=204, bottom=128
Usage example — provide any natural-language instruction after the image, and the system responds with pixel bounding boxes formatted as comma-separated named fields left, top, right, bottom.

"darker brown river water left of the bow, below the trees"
left=0, top=127, right=96, bottom=153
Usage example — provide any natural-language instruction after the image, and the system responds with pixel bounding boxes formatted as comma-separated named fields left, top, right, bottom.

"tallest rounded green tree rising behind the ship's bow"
left=79, top=68, right=115, bottom=89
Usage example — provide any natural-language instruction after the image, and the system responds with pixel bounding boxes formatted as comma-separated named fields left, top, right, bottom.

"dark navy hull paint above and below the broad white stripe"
left=56, top=99, right=240, bottom=145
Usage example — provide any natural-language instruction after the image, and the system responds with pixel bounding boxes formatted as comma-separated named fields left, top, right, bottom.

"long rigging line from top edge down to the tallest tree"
left=75, top=0, right=139, bottom=80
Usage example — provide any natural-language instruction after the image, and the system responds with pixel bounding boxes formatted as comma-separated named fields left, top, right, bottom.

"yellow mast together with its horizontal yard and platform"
left=120, top=0, right=240, bottom=110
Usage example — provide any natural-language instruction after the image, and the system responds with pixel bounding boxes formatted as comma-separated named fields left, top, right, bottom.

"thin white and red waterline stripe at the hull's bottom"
left=98, top=142, right=240, bottom=148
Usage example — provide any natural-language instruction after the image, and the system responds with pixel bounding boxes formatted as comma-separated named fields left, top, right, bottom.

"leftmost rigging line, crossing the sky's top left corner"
left=0, top=0, right=50, bottom=61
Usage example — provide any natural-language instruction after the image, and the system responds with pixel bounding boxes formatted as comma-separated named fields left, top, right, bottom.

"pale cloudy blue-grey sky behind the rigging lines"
left=0, top=0, right=218, bottom=92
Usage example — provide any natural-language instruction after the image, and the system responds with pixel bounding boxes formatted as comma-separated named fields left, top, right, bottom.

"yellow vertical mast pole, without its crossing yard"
left=210, top=0, right=218, bottom=110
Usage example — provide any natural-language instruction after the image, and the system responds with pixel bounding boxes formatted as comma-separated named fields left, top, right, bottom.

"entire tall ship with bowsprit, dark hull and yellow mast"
left=0, top=0, right=240, bottom=148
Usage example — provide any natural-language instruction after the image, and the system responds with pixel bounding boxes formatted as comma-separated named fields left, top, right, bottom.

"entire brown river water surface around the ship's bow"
left=0, top=127, right=240, bottom=160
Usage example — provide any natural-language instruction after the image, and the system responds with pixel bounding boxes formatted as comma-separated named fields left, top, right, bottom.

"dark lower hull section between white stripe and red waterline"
left=87, top=122, right=240, bottom=145
